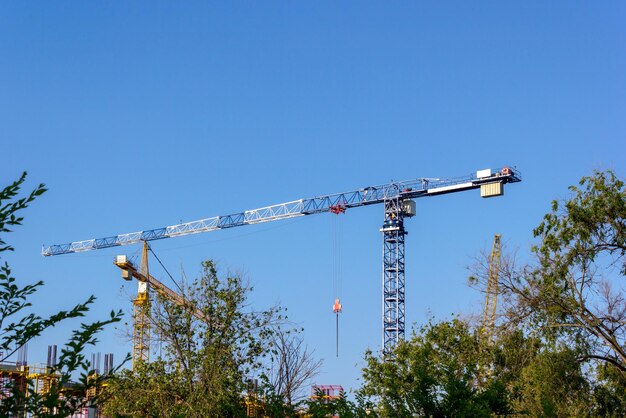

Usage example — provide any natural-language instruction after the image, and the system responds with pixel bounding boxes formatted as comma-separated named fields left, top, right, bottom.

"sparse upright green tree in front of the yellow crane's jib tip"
left=104, top=261, right=281, bottom=417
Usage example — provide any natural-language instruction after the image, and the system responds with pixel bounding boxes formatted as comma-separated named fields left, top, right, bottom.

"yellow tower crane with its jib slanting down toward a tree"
left=113, top=241, right=207, bottom=368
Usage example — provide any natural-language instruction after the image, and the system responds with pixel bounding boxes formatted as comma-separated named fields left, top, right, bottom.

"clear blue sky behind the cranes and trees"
left=0, top=1, right=626, bottom=396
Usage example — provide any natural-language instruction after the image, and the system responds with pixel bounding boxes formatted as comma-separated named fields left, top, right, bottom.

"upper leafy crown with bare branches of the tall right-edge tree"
left=522, top=171, right=626, bottom=372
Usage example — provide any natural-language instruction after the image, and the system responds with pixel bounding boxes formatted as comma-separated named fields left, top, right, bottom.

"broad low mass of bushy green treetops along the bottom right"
left=360, top=319, right=600, bottom=417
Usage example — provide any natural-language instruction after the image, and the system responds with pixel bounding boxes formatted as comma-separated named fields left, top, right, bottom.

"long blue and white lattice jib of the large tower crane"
left=41, top=167, right=521, bottom=256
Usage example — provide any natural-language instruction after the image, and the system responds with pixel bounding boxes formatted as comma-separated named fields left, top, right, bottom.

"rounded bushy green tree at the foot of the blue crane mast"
left=360, top=319, right=509, bottom=417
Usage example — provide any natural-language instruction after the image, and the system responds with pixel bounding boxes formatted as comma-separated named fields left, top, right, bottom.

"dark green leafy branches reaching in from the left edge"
left=0, top=173, right=121, bottom=417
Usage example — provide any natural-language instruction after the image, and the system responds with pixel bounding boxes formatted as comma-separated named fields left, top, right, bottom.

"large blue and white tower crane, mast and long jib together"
left=41, top=167, right=522, bottom=355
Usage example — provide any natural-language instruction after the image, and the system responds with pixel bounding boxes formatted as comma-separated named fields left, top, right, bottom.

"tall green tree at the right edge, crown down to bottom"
left=473, top=171, right=626, bottom=416
